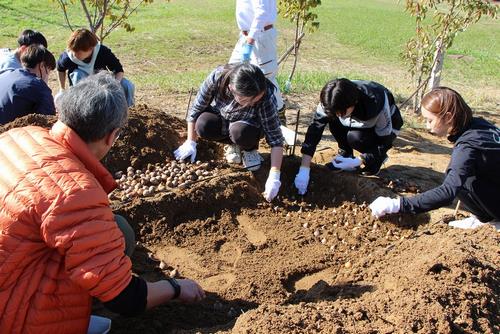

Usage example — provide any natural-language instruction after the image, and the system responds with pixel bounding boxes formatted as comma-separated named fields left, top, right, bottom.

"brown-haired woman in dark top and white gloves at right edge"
left=370, top=87, right=500, bottom=229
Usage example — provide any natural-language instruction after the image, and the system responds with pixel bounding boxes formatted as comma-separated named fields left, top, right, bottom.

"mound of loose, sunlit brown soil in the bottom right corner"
left=232, top=228, right=500, bottom=333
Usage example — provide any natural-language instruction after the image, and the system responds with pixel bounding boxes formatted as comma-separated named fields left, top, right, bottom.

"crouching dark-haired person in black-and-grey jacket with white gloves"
left=295, top=79, right=403, bottom=194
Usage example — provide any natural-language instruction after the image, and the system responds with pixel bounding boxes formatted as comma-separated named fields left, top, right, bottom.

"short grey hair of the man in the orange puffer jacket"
left=56, top=71, right=128, bottom=143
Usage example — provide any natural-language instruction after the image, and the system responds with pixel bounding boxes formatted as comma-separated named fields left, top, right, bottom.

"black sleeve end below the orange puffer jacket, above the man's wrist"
left=104, top=276, right=148, bottom=317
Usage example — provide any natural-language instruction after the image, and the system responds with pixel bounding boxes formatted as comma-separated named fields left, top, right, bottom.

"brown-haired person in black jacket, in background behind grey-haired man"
left=55, top=28, right=135, bottom=107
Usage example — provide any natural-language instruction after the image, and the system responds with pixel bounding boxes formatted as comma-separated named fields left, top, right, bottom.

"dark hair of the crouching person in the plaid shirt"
left=218, top=62, right=267, bottom=99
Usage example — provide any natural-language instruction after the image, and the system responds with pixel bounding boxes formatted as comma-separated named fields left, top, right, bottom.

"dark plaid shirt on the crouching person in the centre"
left=186, top=66, right=284, bottom=147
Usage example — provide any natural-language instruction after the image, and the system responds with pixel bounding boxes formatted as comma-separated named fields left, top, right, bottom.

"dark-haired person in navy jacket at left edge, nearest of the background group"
left=0, top=44, right=56, bottom=124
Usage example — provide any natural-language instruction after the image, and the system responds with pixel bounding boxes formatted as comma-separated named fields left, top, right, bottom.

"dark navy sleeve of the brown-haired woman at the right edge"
left=400, top=146, right=479, bottom=213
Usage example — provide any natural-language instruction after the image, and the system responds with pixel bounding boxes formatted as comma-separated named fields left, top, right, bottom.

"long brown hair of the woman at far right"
left=422, top=87, right=472, bottom=135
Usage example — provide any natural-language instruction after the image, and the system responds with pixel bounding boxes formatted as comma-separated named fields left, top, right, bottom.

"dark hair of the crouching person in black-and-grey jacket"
left=319, top=78, right=359, bottom=117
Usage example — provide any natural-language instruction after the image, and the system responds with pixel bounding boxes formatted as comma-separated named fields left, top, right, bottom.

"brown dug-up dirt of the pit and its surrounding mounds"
left=0, top=106, right=500, bottom=334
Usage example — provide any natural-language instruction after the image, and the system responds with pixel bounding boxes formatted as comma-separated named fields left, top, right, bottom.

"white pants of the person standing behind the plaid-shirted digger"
left=229, top=28, right=283, bottom=110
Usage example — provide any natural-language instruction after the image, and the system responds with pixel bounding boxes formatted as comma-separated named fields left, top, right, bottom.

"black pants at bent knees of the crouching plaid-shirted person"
left=195, top=111, right=262, bottom=151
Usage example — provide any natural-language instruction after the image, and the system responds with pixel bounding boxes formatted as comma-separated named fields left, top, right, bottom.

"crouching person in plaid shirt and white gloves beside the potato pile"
left=174, top=62, right=284, bottom=201
